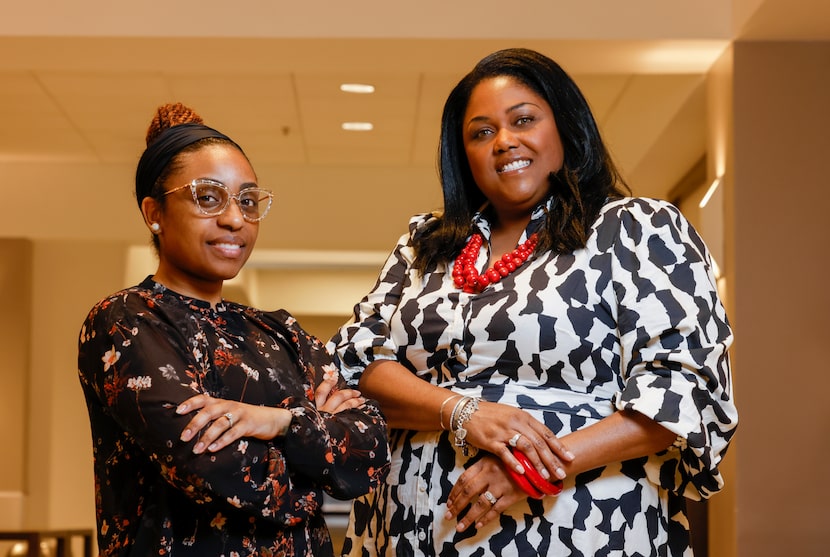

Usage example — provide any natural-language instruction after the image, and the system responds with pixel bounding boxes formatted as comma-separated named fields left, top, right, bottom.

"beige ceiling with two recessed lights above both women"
left=0, top=0, right=830, bottom=255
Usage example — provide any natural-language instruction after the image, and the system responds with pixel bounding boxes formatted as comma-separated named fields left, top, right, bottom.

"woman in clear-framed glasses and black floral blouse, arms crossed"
left=78, top=104, right=389, bottom=557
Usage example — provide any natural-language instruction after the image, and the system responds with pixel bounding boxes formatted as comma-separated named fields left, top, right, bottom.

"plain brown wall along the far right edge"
left=730, top=42, right=830, bottom=557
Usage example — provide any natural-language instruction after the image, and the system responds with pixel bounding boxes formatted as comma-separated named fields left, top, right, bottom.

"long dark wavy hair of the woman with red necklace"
left=413, top=48, right=630, bottom=272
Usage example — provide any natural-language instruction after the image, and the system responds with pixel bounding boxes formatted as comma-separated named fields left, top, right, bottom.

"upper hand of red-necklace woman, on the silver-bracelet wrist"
left=464, top=400, right=574, bottom=480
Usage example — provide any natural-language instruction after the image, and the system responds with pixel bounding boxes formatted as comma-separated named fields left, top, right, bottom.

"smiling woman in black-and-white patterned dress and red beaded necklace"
left=329, top=49, right=737, bottom=556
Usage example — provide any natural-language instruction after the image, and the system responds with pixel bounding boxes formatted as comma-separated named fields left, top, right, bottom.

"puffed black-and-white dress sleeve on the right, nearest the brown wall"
left=599, top=199, right=738, bottom=499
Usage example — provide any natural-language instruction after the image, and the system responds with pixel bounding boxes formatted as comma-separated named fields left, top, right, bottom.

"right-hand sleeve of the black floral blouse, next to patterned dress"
left=258, top=311, right=389, bottom=499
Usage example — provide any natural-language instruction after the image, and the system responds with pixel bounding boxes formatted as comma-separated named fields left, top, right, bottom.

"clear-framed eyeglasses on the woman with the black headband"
left=163, top=178, right=274, bottom=222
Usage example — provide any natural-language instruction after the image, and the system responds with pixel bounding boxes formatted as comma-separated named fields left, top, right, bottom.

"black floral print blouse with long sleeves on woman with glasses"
left=78, top=277, right=389, bottom=557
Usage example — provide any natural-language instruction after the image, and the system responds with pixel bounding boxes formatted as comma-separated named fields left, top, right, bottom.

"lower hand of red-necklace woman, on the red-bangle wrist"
left=444, top=454, right=527, bottom=532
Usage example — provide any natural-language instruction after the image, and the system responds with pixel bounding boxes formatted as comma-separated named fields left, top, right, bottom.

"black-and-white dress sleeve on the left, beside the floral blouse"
left=328, top=214, right=431, bottom=386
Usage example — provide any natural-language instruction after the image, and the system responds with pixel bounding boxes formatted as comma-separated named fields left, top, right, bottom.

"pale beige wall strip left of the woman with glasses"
left=25, top=241, right=129, bottom=528
